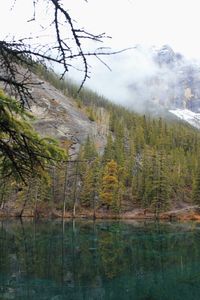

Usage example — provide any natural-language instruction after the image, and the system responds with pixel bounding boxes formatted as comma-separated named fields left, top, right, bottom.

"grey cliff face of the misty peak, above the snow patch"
left=155, top=46, right=200, bottom=112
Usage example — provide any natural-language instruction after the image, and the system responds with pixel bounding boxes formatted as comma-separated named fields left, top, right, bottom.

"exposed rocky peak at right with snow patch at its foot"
left=154, top=45, right=200, bottom=129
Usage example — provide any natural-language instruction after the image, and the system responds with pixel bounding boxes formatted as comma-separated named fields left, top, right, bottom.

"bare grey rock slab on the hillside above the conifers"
left=26, top=74, right=108, bottom=156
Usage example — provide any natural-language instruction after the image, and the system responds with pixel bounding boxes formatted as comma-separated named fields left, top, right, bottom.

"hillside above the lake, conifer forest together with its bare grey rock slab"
left=0, top=69, right=200, bottom=218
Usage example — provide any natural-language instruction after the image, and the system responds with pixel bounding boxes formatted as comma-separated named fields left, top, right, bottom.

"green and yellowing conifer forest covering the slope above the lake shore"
left=0, top=64, right=200, bottom=217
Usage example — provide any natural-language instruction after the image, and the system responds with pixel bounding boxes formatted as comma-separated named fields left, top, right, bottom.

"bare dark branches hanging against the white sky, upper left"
left=0, top=0, right=124, bottom=105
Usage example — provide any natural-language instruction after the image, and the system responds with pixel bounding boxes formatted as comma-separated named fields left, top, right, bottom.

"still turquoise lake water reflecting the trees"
left=0, top=221, right=200, bottom=300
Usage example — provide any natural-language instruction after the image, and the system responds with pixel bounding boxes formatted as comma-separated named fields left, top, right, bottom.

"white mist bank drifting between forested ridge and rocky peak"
left=71, top=46, right=174, bottom=112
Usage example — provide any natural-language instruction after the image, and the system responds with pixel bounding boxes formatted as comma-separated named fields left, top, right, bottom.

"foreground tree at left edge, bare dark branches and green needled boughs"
left=0, top=0, right=123, bottom=180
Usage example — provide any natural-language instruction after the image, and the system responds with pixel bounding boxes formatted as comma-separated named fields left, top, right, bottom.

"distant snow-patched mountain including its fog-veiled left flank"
left=131, top=45, right=200, bottom=128
